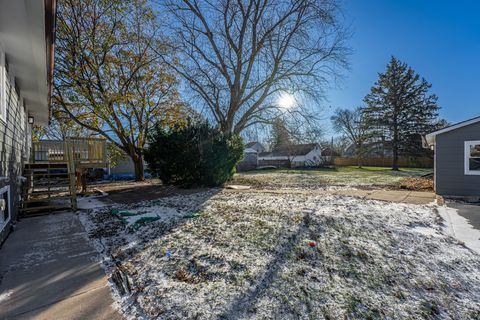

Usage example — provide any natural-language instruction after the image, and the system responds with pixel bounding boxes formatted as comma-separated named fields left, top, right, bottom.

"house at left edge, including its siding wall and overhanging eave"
left=0, top=0, right=55, bottom=243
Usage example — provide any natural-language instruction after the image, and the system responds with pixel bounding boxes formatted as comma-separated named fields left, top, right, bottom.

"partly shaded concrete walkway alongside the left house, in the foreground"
left=0, top=213, right=122, bottom=320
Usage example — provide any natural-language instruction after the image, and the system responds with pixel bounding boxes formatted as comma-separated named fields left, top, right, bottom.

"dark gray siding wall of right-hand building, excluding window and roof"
left=435, top=123, right=480, bottom=196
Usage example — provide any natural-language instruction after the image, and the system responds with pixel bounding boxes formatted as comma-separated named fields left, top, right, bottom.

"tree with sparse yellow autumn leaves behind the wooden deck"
left=53, top=0, right=188, bottom=180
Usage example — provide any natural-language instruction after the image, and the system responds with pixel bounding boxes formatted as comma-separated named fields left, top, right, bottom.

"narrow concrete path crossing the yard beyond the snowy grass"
left=225, top=186, right=435, bottom=204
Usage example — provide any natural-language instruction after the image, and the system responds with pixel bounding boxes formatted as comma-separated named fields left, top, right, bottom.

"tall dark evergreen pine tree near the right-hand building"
left=363, top=57, right=439, bottom=170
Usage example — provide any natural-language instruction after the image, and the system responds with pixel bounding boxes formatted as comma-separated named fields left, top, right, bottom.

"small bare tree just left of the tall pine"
left=331, top=108, right=369, bottom=168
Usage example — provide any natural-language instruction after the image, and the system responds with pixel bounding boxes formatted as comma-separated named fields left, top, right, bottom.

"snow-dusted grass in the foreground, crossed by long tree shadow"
left=82, top=190, right=480, bottom=319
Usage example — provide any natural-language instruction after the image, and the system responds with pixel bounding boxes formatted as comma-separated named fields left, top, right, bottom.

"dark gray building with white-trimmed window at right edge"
left=425, top=117, right=480, bottom=197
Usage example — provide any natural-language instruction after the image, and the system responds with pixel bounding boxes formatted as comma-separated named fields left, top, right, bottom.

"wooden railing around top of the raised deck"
left=31, top=138, right=107, bottom=167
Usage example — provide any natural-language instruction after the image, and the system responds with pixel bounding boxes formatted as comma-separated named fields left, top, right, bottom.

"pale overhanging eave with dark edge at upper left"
left=0, top=0, right=55, bottom=124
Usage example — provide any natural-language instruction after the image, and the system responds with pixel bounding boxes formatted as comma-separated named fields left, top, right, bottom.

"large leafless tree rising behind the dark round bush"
left=161, top=0, right=349, bottom=133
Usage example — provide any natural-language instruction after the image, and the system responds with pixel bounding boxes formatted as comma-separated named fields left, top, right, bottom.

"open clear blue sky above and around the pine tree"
left=326, top=0, right=480, bottom=133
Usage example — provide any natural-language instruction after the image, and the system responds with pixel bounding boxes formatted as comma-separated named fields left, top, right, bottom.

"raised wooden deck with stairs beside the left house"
left=21, top=137, right=107, bottom=216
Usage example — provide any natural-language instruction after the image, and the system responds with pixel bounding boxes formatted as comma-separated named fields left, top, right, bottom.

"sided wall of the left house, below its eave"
left=0, top=67, right=31, bottom=242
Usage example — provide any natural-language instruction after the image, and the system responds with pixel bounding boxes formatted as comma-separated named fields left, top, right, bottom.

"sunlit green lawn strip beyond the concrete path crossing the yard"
left=231, top=166, right=433, bottom=189
